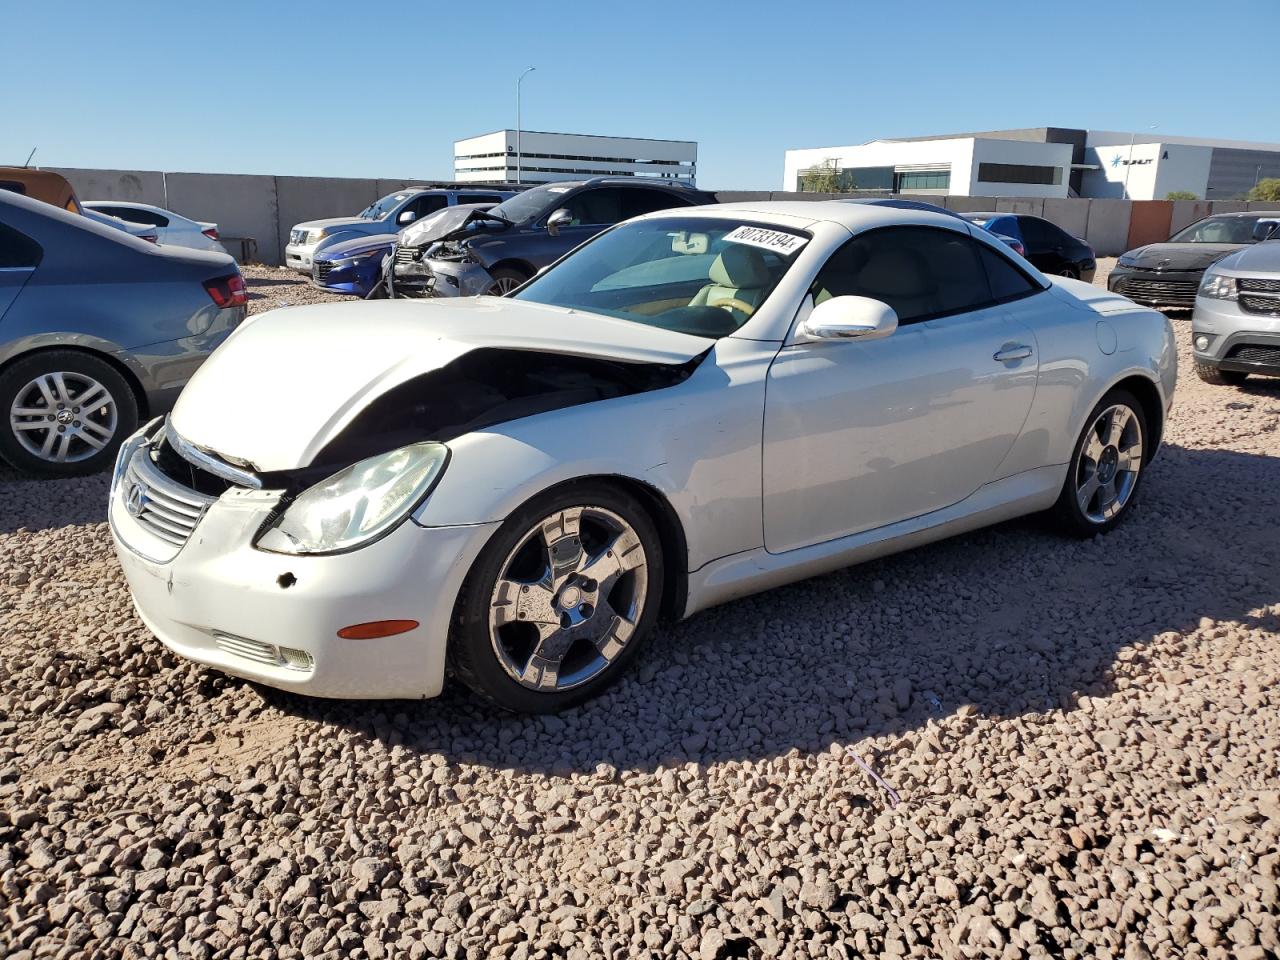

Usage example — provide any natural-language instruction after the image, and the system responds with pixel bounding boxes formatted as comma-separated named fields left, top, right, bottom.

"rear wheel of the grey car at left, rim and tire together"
left=0, top=351, right=138, bottom=476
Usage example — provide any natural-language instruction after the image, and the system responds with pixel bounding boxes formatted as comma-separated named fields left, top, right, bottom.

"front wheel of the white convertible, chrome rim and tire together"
left=449, top=483, right=663, bottom=713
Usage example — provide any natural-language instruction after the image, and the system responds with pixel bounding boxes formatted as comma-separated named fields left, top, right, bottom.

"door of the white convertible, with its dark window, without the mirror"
left=763, top=227, right=1037, bottom=553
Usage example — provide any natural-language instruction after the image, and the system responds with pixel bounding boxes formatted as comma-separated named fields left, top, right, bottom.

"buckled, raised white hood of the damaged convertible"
left=170, top=297, right=714, bottom=472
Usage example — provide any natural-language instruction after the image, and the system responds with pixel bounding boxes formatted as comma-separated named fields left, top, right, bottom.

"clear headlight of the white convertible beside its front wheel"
left=256, top=443, right=449, bottom=554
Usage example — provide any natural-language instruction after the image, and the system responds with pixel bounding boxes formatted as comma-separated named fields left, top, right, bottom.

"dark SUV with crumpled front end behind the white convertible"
left=388, top=177, right=716, bottom=297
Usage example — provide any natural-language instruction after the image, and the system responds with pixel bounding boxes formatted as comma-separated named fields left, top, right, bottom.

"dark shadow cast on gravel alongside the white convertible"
left=262, top=444, right=1280, bottom=788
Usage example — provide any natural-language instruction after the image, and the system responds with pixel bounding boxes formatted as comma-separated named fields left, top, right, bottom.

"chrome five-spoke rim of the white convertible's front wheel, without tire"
left=489, top=506, right=649, bottom=692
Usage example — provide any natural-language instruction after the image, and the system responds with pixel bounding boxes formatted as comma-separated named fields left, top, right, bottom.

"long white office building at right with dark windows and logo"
left=782, top=127, right=1280, bottom=200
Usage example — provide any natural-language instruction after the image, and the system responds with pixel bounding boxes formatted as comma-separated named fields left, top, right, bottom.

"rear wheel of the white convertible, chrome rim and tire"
left=1053, top=389, right=1148, bottom=536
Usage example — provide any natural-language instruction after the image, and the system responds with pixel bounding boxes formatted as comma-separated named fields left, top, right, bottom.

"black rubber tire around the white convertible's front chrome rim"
left=448, top=481, right=663, bottom=713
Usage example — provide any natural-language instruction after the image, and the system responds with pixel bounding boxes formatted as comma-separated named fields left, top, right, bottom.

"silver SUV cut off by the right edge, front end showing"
left=1192, top=215, right=1280, bottom=385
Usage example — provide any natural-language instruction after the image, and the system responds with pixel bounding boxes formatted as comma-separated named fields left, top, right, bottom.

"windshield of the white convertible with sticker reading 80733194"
left=512, top=216, right=809, bottom=338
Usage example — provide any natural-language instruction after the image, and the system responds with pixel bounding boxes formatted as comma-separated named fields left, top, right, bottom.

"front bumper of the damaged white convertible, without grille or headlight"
left=108, top=430, right=498, bottom=699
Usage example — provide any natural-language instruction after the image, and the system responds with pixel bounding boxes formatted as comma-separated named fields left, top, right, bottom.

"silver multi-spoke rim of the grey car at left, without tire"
left=9, top=371, right=118, bottom=463
